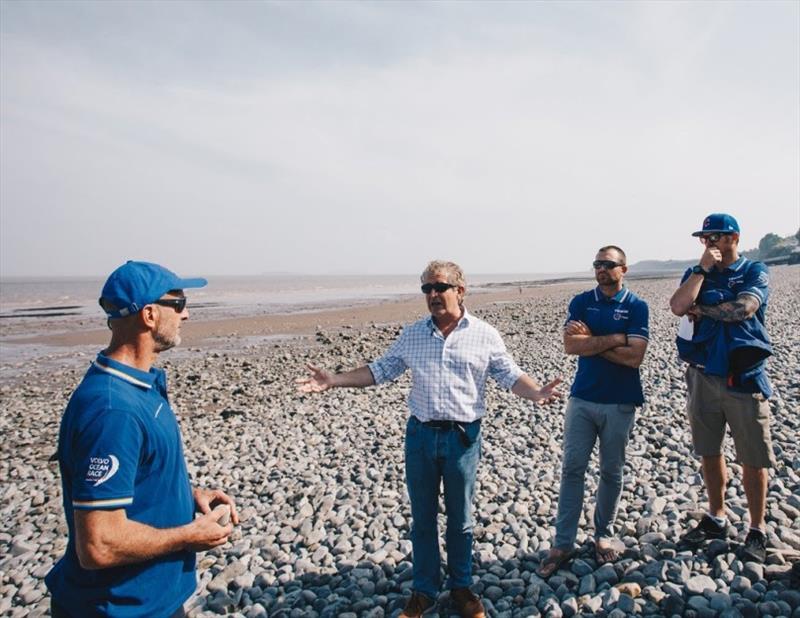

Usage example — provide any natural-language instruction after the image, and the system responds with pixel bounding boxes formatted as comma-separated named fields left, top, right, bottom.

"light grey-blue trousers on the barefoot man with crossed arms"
left=555, top=397, right=636, bottom=549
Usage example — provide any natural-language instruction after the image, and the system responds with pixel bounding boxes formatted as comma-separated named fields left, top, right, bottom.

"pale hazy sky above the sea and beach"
left=0, top=0, right=800, bottom=276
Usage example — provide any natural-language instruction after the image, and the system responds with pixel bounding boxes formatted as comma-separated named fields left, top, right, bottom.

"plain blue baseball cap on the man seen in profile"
left=100, top=260, right=208, bottom=318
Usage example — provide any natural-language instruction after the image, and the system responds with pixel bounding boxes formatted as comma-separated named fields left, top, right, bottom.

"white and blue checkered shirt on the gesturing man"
left=368, top=310, right=524, bottom=423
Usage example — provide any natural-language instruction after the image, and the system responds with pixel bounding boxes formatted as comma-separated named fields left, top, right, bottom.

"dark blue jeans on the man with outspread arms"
left=405, top=416, right=481, bottom=599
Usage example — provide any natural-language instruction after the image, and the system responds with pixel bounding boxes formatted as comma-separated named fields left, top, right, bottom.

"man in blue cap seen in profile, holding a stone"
left=45, top=261, right=238, bottom=618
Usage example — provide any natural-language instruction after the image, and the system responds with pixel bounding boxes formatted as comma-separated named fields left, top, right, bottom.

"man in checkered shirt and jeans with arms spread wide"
left=298, top=261, right=561, bottom=618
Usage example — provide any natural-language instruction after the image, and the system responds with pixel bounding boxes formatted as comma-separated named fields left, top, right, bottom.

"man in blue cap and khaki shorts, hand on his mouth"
left=670, top=213, right=775, bottom=562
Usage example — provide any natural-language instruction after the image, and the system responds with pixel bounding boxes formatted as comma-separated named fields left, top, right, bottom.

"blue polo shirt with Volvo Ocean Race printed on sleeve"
left=45, top=354, right=196, bottom=618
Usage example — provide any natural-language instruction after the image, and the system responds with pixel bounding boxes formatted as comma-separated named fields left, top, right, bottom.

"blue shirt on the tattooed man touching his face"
left=681, top=256, right=772, bottom=397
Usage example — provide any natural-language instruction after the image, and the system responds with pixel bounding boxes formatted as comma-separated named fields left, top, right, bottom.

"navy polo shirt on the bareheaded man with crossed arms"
left=567, top=287, right=650, bottom=406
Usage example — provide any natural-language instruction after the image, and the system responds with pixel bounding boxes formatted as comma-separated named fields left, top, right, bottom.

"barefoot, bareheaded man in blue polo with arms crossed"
left=537, top=245, right=649, bottom=577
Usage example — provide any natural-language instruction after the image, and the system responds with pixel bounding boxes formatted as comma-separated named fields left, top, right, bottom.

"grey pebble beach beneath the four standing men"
left=0, top=267, right=800, bottom=618
